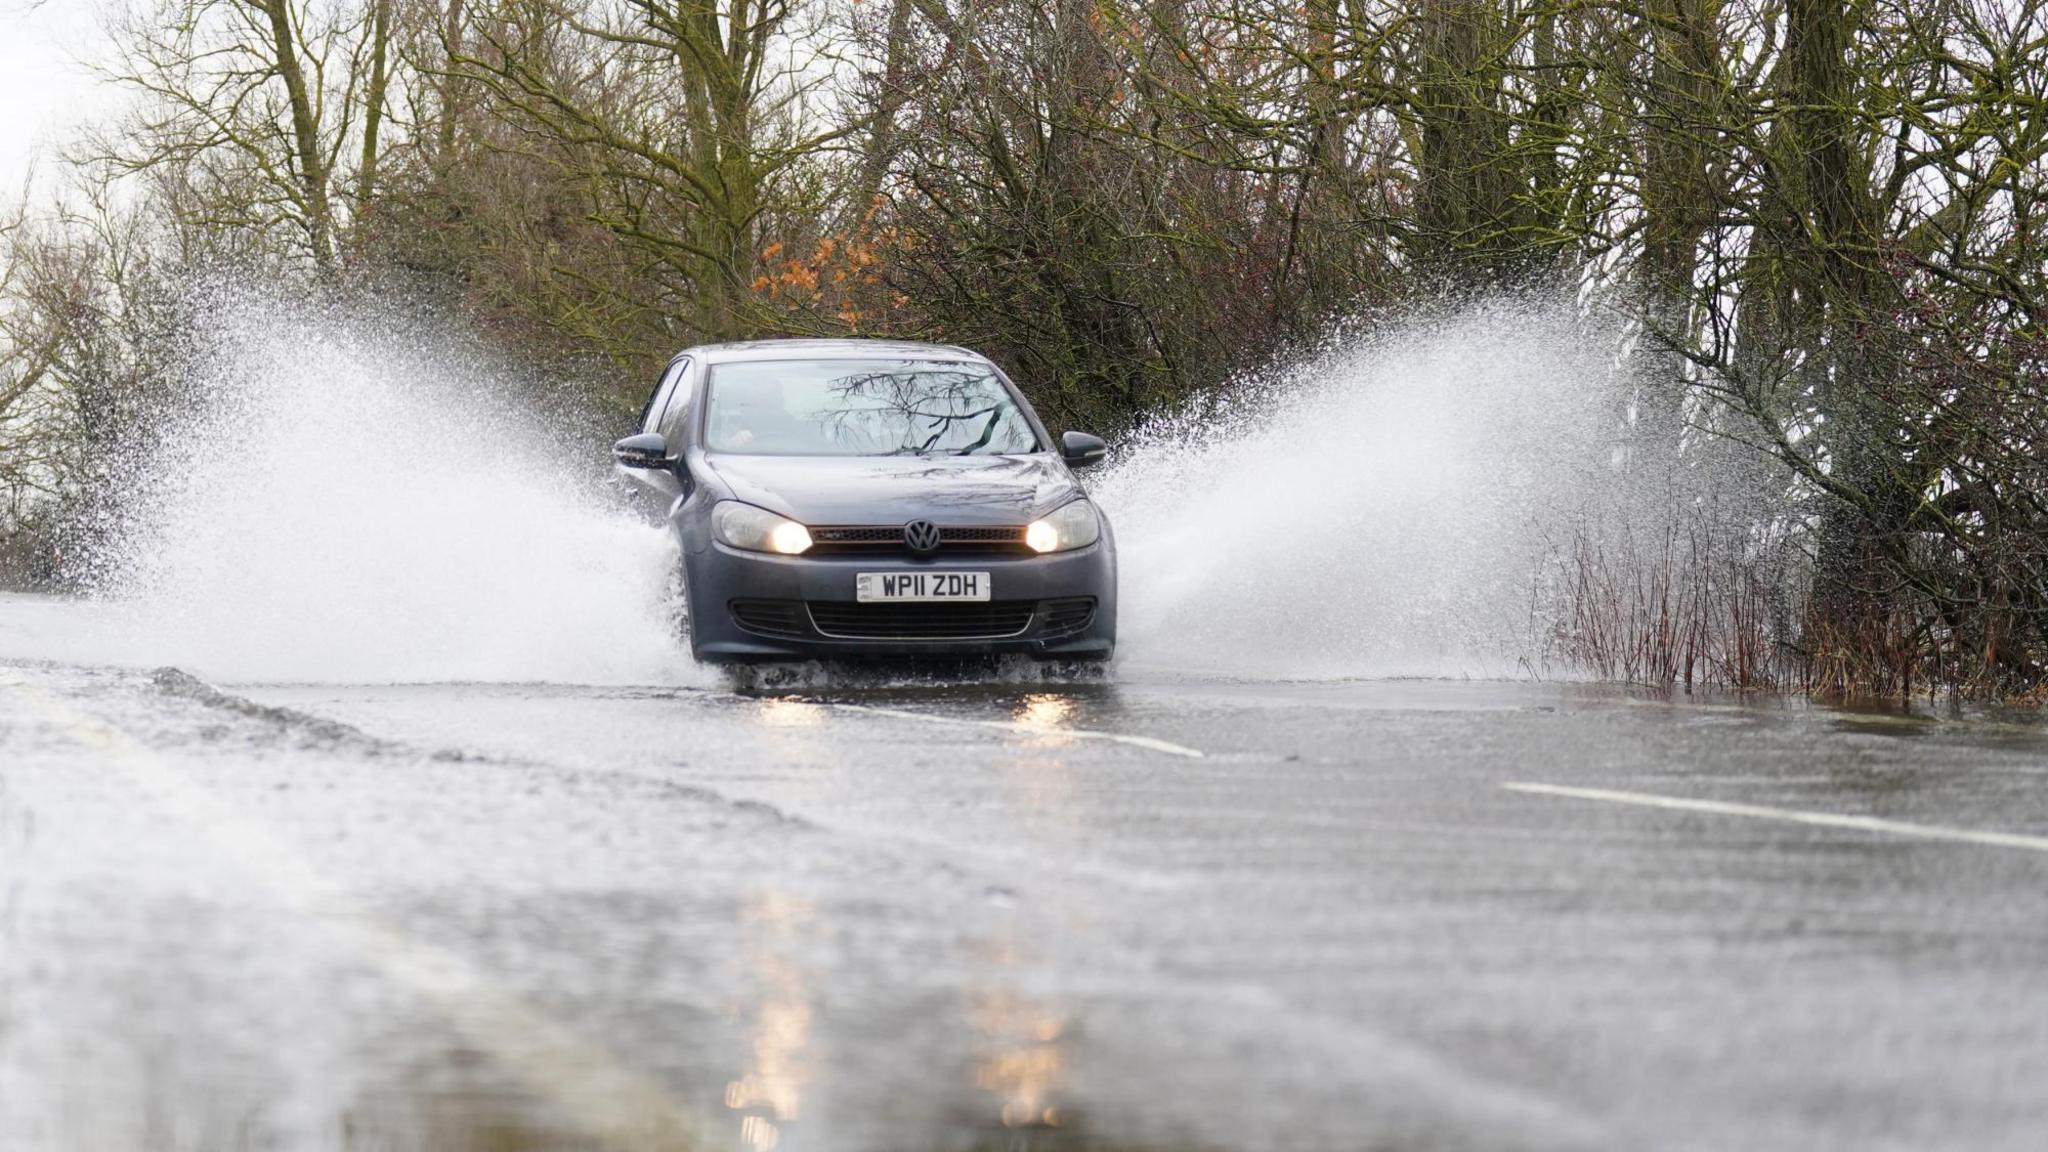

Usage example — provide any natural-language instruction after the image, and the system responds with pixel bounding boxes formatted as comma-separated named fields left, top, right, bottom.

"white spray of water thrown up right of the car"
left=1094, top=299, right=1620, bottom=676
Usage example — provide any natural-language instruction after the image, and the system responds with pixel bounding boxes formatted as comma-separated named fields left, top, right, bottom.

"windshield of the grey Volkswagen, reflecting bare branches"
left=705, top=361, right=1038, bottom=455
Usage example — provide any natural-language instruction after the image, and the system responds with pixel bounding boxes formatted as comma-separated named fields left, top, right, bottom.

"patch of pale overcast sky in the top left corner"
left=0, top=0, right=121, bottom=201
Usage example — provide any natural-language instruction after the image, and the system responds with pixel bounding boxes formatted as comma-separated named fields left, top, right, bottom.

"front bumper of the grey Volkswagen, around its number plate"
left=682, top=533, right=1116, bottom=662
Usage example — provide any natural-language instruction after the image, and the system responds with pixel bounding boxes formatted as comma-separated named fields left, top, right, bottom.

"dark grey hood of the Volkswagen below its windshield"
left=709, top=453, right=1079, bottom=525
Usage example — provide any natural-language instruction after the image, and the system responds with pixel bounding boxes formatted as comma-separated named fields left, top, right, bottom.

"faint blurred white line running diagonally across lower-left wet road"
left=0, top=672, right=717, bottom=1152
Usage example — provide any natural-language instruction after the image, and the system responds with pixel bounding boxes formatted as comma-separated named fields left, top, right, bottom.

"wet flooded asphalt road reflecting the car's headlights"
left=0, top=599, right=2048, bottom=1152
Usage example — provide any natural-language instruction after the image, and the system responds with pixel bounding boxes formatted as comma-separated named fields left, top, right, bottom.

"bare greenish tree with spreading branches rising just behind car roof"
left=451, top=0, right=848, bottom=336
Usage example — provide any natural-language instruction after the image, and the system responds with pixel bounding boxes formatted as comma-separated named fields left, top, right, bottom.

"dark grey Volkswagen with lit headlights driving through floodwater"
left=612, top=340, right=1116, bottom=662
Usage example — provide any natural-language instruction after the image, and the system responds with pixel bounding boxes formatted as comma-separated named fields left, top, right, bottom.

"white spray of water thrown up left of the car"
left=81, top=291, right=690, bottom=681
